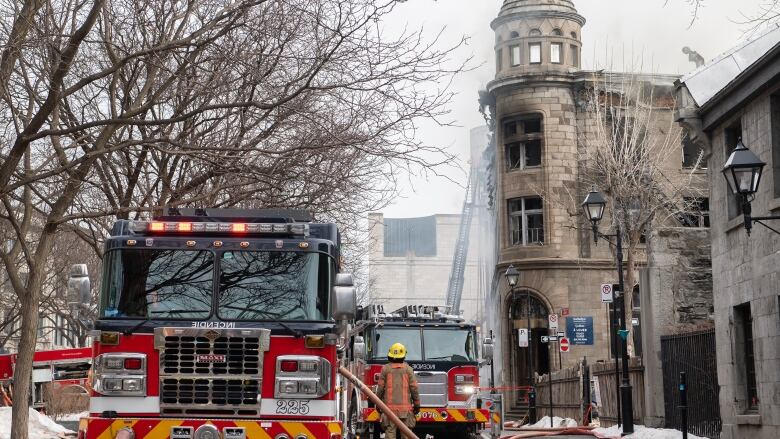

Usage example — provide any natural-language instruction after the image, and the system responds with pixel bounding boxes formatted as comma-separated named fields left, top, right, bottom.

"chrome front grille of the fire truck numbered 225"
left=155, top=328, right=270, bottom=417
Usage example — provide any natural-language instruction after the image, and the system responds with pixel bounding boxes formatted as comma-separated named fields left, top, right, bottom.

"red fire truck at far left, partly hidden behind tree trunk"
left=0, top=348, right=92, bottom=409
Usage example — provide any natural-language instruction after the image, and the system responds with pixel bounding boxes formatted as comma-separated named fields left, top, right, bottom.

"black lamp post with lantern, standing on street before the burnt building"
left=582, top=186, right=634, bottom=435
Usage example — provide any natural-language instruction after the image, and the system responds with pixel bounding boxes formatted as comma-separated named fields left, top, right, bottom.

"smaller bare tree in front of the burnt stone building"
left=573, top=73, right=706, bottom=354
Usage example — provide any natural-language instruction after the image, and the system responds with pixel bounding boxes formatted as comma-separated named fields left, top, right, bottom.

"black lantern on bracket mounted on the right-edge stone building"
left=723, top=139, right=780, bottom=236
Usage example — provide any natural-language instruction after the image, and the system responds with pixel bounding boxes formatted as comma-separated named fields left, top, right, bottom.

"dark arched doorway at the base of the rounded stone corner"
left=508, top=289, right=550, bottom=386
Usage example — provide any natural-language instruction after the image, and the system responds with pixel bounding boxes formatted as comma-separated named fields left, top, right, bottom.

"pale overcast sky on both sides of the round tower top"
left=383, top=0, right=766, bottom=217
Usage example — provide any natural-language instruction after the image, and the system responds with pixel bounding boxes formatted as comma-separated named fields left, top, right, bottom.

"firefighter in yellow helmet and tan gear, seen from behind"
left=376, top=343, right=420, bottom=439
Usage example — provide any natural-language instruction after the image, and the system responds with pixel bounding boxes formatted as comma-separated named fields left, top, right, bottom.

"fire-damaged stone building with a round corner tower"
left=481, top=0, right=705, bottom=412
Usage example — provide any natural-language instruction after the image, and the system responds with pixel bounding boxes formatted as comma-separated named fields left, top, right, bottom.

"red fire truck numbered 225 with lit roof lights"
left=74, top=209, right=355, bottom=439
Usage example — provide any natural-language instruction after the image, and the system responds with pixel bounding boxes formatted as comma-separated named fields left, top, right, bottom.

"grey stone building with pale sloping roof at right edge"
left=677, top=25, right=780, bottom=439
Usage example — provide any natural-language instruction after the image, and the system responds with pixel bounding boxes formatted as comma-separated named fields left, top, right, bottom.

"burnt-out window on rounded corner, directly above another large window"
left=504, top=115, right=542, bottom=170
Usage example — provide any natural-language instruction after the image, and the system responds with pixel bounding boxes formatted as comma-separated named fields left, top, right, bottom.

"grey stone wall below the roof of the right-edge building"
left=709, top=83, right=780, bottom=439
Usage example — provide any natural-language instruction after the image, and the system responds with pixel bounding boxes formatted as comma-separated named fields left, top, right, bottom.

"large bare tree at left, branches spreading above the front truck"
left=0, top=0, right=463, bottom=439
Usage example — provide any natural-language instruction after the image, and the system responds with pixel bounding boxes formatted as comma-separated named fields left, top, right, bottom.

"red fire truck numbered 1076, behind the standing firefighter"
left=347, top=305, right=489, bottom=439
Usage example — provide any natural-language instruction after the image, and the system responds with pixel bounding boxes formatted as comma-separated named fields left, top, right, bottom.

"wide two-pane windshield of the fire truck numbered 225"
left=100, top=249, right=335, bottom=320
